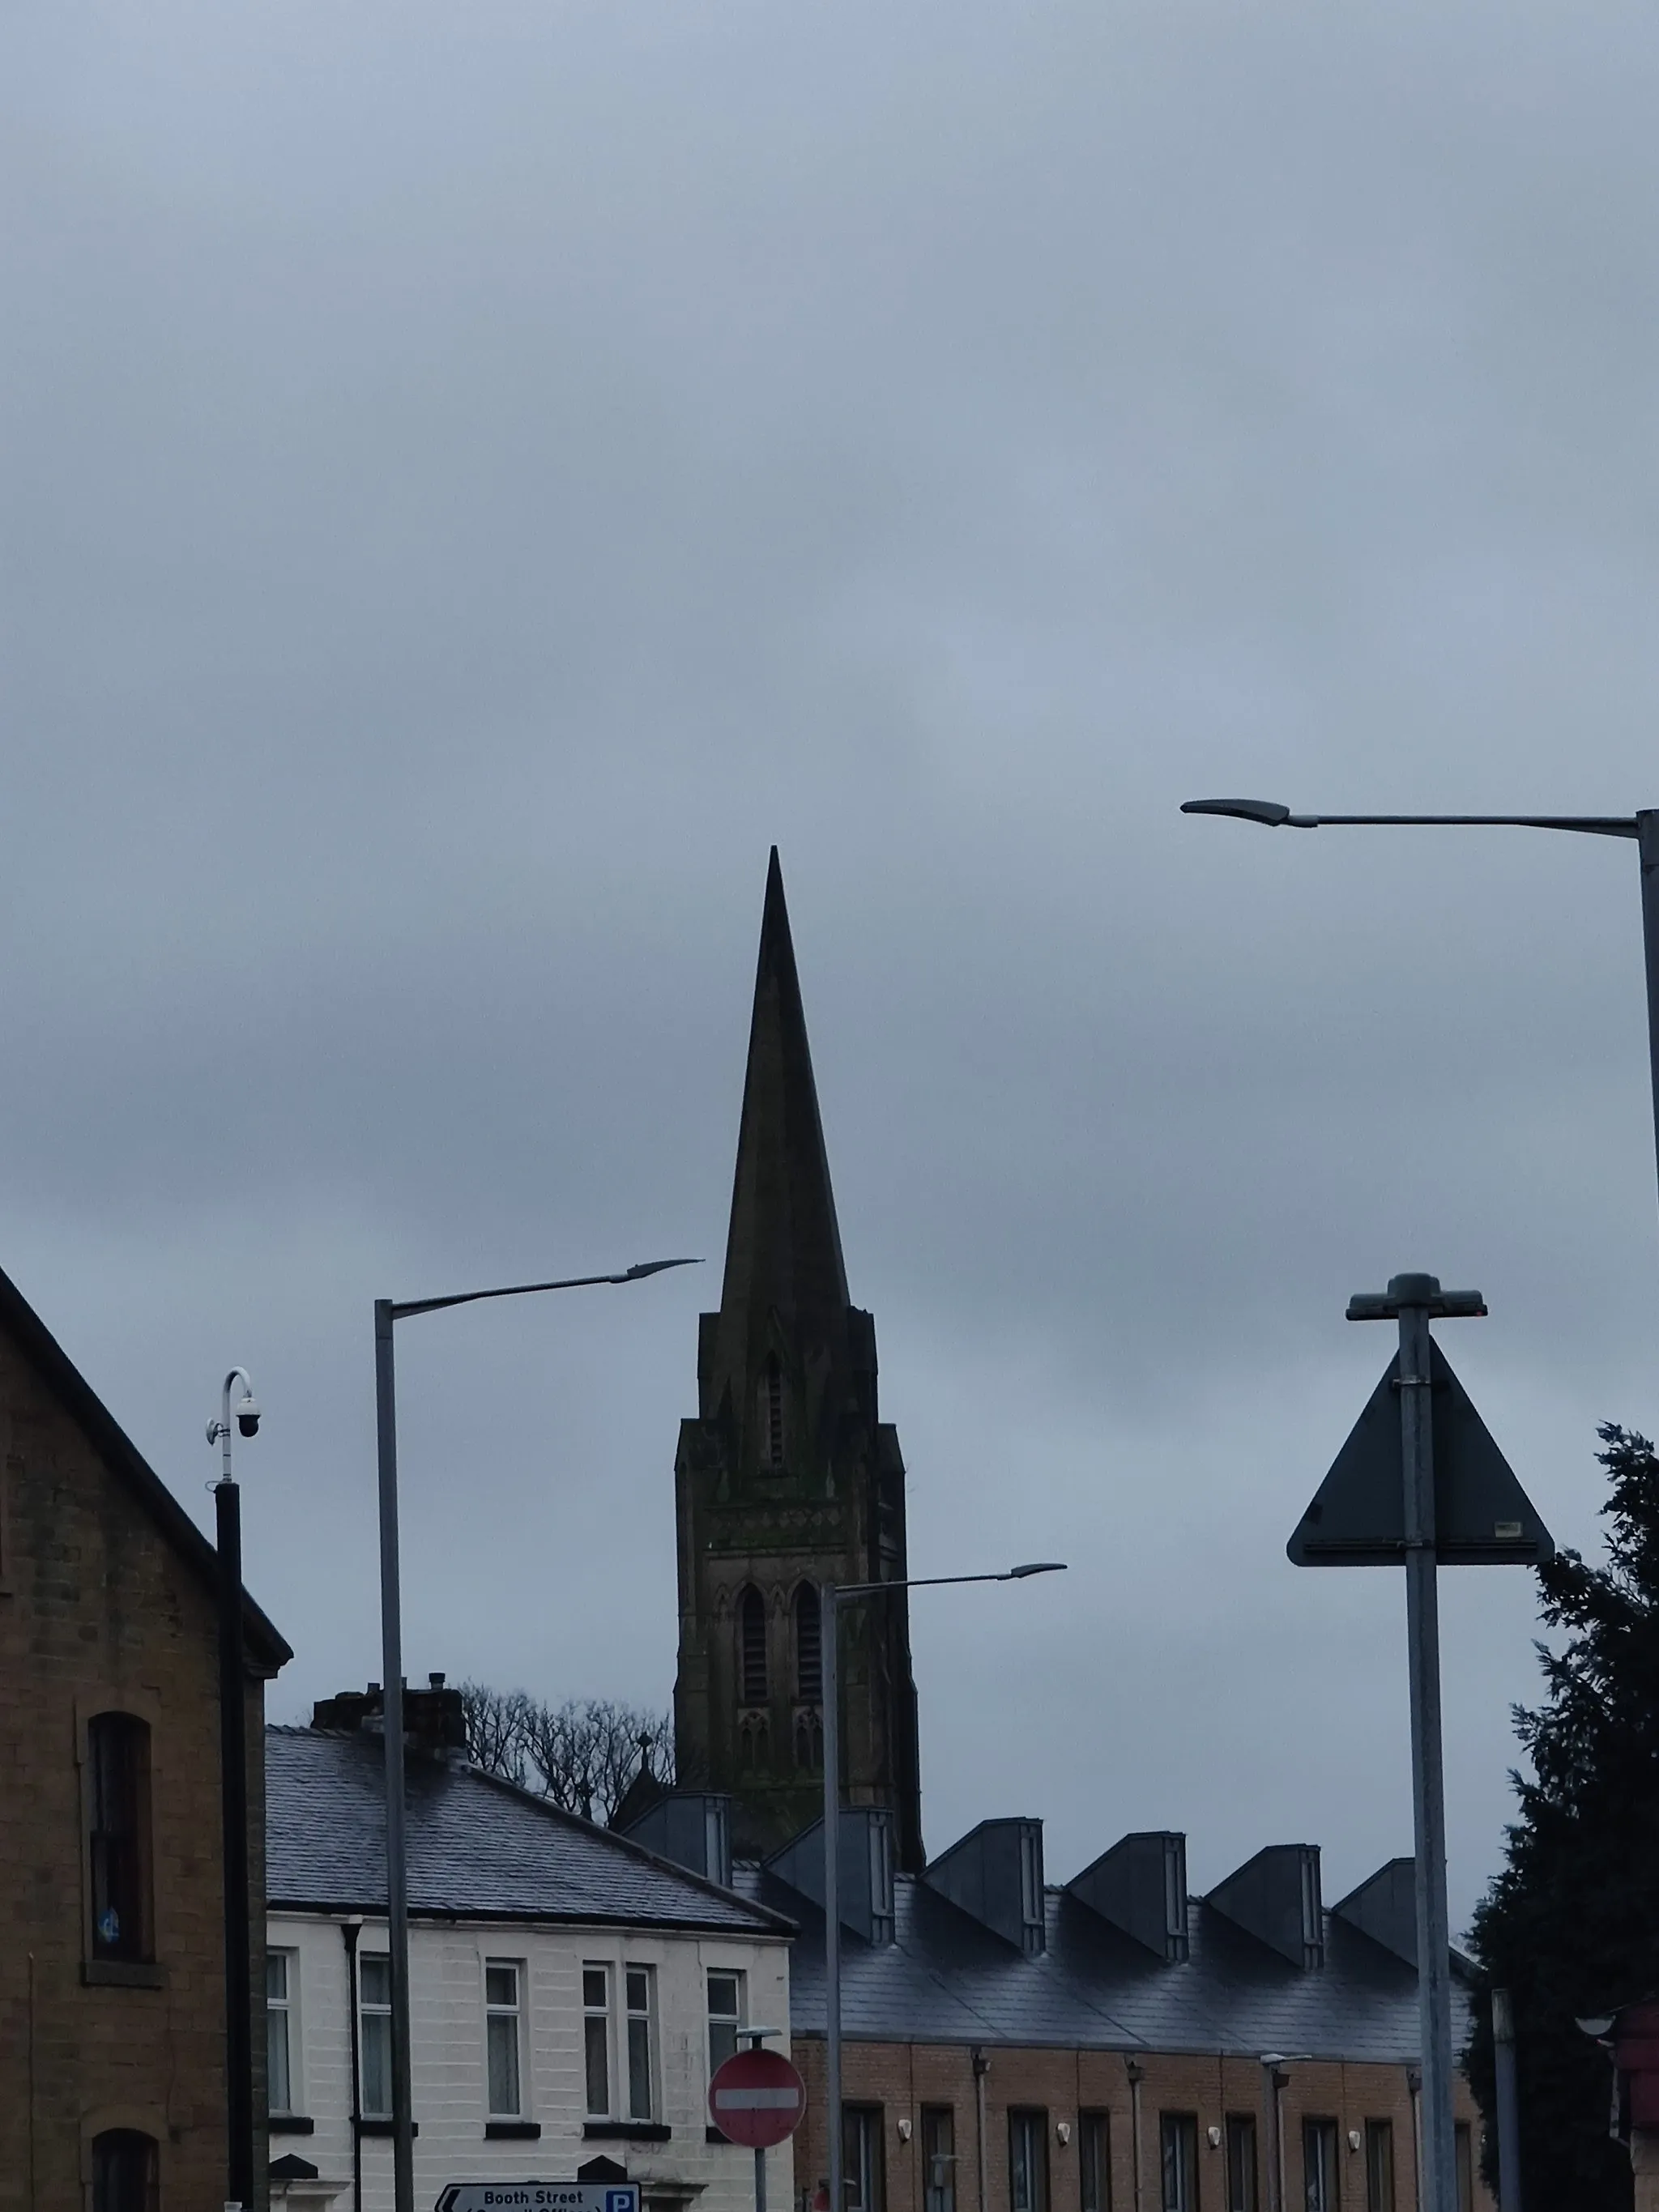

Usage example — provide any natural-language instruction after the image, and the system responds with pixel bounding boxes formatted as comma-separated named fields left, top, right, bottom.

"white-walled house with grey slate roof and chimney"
left=266, top=1688, right=794, bottom=2212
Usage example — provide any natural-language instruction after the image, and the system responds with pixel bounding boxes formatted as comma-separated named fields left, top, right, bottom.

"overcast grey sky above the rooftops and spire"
left=0, top=0, right=1659, bottom=1920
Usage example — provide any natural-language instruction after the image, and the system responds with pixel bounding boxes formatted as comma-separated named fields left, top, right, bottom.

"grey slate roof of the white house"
left=266, top=1728, right=792, bottom=1936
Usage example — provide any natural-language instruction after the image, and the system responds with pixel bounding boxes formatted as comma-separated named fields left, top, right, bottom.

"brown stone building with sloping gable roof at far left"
left=0, top=1274, right=290, bottom=2212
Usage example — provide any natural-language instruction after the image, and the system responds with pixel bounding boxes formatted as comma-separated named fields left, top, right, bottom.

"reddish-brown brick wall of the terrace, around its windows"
left=794, top=2037, right=1493, bottom=2212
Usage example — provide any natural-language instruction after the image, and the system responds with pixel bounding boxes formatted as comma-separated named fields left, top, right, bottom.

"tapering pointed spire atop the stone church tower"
left=719, top=845, right=850, bottom=1378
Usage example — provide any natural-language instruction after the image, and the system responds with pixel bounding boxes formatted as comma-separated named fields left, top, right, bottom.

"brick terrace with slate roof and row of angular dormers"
left=745, top=1812, right=1491, bottom=2212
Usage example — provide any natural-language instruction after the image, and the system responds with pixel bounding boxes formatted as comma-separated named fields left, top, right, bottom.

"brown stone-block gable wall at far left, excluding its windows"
left=0, top=1332, right=267, bottom=2212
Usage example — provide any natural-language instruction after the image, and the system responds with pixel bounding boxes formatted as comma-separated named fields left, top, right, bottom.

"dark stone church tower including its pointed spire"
left=675, top=847, right=937, bottom=1869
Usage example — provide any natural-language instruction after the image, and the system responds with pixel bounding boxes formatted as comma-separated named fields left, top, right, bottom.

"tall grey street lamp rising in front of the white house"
left=373, top=1259, right=699, bottom=2212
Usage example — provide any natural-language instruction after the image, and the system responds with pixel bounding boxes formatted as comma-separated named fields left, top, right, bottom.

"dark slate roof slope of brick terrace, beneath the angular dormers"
left=735, top=1865, right=1469, bottom=2064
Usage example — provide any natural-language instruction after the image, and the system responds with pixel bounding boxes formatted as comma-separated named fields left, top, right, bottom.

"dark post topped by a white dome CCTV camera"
left=208, top=1367, right=258, bottom=2212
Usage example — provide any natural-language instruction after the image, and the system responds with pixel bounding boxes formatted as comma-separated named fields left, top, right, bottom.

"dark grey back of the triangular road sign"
left=1286, top=1338, right=1555, bottom=1566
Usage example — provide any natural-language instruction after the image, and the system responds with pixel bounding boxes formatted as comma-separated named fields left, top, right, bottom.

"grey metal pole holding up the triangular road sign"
left=1389, top=1276, right=1458, bottom=2212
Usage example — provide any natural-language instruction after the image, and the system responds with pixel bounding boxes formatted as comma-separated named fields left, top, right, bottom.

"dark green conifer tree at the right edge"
left=1466, top=1425, right=1659, bottom=2212
